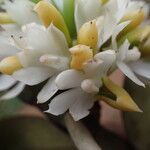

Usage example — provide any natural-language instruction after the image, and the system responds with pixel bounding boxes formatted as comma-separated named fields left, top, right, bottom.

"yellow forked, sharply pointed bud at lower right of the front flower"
left=98, top=78, right=142, bottom=112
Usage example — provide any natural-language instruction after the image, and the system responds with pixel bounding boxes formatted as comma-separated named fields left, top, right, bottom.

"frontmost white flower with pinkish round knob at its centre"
left=47, top=50, right=116, bottom=121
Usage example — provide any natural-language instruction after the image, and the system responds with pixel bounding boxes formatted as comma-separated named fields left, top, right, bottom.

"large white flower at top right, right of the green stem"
left=75, top=0, right=149, bottom=47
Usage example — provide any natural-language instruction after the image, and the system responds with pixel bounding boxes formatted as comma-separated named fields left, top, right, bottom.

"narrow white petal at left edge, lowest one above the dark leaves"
left=0, top=83, right=25, bottom=100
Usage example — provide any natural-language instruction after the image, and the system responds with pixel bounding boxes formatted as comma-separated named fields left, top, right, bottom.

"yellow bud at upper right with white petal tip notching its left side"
left=121, top=10, right=145, bottom=35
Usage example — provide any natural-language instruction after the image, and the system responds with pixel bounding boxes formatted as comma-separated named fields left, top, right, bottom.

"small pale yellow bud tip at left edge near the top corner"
left=0, top=12, right=14, bottom=24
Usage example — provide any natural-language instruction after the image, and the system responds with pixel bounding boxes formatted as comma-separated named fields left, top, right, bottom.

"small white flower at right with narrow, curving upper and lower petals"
left=112, top=22, right=145, bottom=87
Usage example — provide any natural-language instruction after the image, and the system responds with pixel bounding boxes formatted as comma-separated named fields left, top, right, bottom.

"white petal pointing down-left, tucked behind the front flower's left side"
left=37, top=76, right=58, bottom=103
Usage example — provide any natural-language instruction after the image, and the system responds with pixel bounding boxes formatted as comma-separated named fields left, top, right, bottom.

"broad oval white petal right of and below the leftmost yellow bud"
left=13, top=67, right=55, bottom=85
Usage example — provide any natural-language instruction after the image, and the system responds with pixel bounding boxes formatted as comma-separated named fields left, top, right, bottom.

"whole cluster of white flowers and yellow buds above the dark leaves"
left=0, top=0, right=150, bottom=121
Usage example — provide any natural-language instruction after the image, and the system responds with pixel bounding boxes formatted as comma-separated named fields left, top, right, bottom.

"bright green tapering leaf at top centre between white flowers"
left=52, top=0, right=76, bottom=38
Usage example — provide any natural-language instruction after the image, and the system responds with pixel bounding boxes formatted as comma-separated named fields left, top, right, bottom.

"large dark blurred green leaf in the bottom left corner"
left=0, top=117, right=75, bottom=150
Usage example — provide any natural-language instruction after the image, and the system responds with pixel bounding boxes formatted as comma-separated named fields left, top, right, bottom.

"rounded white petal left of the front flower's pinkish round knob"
left=55, top=69, right=85, bottom=90
